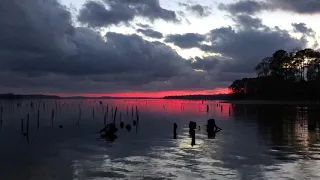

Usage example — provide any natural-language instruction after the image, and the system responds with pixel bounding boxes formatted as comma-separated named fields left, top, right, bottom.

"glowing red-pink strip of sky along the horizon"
left=57, top=88, right=231, bottom=98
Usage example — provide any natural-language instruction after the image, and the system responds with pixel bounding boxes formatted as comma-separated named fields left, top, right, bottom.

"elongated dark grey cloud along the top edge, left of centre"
left=78, top=0, right=178, bottom=27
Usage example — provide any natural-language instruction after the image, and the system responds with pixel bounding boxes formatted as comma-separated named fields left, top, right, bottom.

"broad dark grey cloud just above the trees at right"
left=188, top=15, right=307, bottom=74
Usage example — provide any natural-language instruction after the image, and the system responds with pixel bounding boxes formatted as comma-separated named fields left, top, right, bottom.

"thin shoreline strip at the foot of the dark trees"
left=220, top=100, right=320, bottom=105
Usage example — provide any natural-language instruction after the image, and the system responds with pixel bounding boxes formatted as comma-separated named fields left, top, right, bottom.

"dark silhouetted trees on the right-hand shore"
left=229, top=48, right=320, bottom=100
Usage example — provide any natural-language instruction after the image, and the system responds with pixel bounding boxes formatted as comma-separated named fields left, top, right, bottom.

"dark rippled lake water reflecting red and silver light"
left=0, top=100, right=320, bottom=180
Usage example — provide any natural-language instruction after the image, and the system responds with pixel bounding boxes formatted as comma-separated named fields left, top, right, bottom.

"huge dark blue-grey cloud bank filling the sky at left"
left=0, top=0, right=208, bottom=93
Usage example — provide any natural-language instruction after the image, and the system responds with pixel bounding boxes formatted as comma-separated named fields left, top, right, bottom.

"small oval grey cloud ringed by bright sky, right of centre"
left=165, top=33, right=206, bottom=48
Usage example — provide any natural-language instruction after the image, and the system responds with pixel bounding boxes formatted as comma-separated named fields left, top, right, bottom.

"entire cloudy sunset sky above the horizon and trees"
left=0, top=0, right=320, bottom=97
